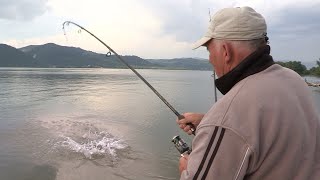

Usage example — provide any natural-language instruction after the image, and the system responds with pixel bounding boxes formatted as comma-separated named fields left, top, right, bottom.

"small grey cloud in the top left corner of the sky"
left=0, top=0, right=48, bottom=21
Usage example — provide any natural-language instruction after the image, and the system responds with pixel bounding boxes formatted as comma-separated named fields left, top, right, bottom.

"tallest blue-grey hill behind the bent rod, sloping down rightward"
left=20, top=43, right=153, bottom=68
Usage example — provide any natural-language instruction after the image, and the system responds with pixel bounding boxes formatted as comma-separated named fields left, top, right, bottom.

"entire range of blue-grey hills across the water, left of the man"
left=0, top=43, right=211, bottom=70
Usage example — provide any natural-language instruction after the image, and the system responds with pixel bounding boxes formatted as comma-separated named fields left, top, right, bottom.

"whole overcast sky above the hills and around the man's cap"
left=0, top=0, right=320, bottom=62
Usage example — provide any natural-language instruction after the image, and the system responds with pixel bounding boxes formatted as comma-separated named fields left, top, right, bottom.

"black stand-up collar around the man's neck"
left=215, top=45, right=274, bottom=95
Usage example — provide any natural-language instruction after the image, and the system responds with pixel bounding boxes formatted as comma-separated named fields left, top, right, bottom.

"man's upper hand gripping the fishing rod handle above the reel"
left=177, top=113, right=204, bottom=135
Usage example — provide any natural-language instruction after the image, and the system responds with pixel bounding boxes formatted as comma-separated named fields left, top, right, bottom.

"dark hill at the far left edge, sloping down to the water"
left=0, top=44, right=38, bottom=67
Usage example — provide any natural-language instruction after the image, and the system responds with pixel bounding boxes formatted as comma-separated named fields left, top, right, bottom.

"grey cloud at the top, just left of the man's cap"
left=142, top=0, right=232, bottom=43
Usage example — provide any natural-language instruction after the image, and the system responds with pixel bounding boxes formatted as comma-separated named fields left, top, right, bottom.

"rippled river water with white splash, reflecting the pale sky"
left=0, top=68, right=320, bottom=180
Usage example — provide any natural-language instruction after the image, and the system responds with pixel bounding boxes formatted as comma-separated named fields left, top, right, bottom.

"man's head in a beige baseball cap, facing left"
left=194, top=7, right=268, bottom=77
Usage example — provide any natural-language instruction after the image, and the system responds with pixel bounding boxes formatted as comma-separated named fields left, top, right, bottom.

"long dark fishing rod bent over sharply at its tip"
left=62, top=21, right=195, bottom=135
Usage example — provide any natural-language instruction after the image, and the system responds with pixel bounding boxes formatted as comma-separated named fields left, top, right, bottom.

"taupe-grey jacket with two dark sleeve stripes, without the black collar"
left=181, top=64, right=320, bottom=180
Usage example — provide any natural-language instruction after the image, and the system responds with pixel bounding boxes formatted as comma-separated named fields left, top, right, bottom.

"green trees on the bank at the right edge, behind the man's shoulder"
left=276, top=58, right=320, bottom=77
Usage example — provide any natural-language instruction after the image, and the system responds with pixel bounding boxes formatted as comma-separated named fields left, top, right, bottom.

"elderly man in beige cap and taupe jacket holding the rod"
left=177, top=7, right=320, bottom=180
